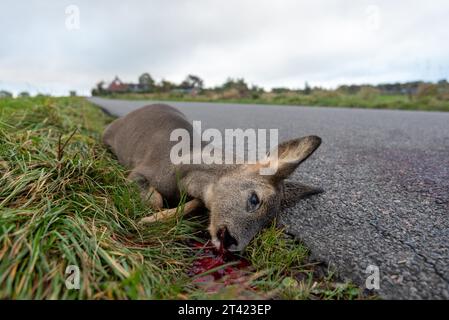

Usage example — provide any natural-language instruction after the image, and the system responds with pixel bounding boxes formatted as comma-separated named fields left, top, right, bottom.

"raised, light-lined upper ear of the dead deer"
left=268, top=136, right=321, bottom=180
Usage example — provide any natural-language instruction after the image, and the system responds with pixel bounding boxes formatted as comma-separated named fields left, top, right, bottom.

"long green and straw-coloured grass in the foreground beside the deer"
left=0, top=97, right=362, bottom=299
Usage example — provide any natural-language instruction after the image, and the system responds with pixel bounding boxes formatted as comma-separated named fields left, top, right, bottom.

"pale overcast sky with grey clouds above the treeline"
left=0, top=0, right=449, bottom=95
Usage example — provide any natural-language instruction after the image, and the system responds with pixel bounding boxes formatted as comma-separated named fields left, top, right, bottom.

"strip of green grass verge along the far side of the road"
left=106, top=90, right=449, bottom=111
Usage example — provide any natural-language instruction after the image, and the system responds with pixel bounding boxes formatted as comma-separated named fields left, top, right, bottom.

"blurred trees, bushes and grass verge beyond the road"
left=92, top=73, right=449, bottom=111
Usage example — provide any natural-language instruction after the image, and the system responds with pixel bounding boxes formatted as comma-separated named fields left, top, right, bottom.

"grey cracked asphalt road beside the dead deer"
left=90, top=98, right=449, bottom=299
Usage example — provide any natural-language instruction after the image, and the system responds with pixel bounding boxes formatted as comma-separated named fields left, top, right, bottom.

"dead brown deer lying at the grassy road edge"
left=103, top=104, right=321, bottom=251
